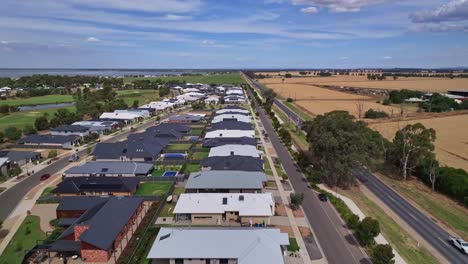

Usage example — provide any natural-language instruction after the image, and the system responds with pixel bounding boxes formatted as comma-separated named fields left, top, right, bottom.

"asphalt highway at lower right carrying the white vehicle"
left=355, top=170, right=468, bottom=263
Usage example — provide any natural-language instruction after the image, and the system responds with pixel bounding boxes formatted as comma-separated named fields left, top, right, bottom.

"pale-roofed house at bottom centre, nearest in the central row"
left=147, top=227, right=289, bottom=264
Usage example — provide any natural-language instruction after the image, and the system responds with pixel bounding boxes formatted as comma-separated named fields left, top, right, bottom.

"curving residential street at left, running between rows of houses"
left=0, top=109, right=183, bottom=221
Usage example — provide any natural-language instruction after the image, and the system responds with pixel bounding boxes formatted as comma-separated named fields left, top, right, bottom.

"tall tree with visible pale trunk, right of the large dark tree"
left=391, top=123, right=436, bottom=180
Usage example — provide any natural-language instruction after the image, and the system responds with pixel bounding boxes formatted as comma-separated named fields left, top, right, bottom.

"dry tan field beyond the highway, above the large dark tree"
left=265, top=81, right=399, bottom=116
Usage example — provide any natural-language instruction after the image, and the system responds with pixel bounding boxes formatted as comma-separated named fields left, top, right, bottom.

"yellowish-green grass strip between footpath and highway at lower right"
left=340, top=190, right=438, bottom=264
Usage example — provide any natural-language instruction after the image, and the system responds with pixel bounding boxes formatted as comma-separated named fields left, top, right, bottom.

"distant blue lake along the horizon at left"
left=0, top=69, right=208, bottom=78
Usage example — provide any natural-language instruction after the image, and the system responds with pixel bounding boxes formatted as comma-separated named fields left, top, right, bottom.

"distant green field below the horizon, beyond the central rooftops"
left=124, top=73, right=245, bottom=84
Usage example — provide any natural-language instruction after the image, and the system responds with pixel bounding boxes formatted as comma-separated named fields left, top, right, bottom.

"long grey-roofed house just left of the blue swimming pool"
left=64, top=161, right=153, bottom=177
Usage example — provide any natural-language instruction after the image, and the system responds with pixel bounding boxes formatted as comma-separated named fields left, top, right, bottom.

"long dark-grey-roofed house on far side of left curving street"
left=16, top=134, right=80, bottom=149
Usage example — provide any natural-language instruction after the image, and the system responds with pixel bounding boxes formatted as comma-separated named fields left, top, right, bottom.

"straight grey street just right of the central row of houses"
left=243, top=75, right=370, bottom=263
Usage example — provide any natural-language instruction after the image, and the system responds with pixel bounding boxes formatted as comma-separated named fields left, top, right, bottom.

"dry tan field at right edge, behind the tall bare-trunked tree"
left=371, top=115, right=468, bottom=170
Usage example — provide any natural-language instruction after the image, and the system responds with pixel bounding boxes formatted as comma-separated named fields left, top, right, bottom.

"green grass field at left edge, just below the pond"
left=0, top=106, right=76, bottom=131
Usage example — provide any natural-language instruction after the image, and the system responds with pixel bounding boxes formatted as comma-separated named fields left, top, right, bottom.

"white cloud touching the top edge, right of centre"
left=292, top=0, right=392, bottom=13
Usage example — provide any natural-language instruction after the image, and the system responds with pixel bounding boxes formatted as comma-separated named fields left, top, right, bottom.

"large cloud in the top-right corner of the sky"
left=410, top=0, right=468, bottom=23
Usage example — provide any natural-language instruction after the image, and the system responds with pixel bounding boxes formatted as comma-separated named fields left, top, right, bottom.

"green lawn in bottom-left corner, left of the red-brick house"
left=0, top=215, right=46, bottom=264
